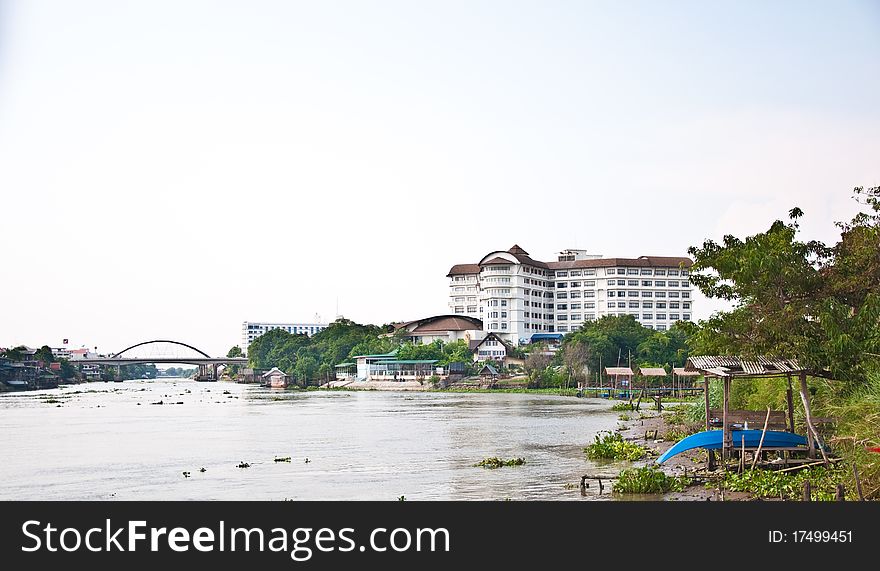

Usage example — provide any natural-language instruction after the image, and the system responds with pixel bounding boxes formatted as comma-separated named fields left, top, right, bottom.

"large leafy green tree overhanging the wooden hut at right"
left=688, top=187, right=880, bottom=384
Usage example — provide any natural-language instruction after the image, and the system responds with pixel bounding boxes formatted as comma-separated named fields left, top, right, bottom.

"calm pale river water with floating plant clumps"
left=0, top=379, right=617, bottom=500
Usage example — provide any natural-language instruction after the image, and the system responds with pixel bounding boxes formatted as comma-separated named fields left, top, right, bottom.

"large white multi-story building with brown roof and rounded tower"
left=447, top=245, right=693, bottom=344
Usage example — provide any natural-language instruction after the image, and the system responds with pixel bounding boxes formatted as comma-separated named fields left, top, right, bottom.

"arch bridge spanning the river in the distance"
left=74, top=339, right=248, bottom=381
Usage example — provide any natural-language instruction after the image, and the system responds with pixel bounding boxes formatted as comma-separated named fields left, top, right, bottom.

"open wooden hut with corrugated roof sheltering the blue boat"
left=685, top=355, right=824, bottom=465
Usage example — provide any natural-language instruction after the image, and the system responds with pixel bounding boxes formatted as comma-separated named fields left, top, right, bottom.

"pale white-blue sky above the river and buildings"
left=0, top=0, right=880, bottom=355
